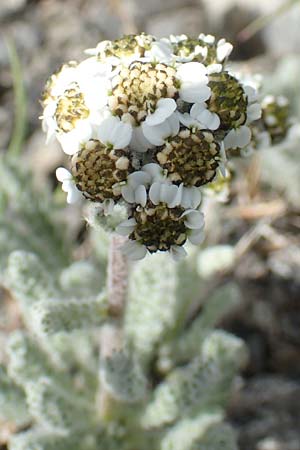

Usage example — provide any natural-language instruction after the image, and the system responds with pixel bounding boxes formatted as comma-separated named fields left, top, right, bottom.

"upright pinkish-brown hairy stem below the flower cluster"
left=98, top=235, right=128, bottom=421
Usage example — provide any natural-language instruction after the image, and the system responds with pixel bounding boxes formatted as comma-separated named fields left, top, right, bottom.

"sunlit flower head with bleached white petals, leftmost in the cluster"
left=43, top=60, right=111, bottom=155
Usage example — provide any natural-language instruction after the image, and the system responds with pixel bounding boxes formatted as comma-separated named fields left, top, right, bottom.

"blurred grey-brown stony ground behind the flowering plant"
left=0, top=0, right=300, bottom=450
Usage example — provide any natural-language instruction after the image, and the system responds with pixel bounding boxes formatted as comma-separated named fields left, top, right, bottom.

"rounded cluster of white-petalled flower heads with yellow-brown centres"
left=39, top=34, right=286, bottom=259
